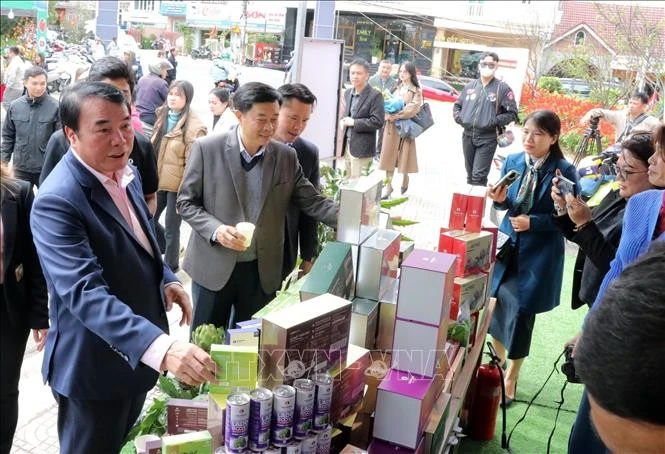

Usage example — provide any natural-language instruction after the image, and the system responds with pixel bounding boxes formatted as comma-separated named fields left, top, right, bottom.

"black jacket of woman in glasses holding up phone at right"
left=554, top=190, right=626, bottom=309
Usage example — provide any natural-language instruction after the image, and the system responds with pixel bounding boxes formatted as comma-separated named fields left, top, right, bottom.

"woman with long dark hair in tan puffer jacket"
left=152, top=80, right=207, bottom=272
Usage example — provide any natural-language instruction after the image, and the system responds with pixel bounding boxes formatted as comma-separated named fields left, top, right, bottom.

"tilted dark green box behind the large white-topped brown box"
left=300, top=241, right=355, bottom=301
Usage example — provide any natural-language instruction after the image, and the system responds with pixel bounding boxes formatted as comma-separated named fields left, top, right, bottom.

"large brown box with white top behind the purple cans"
left=259, top=294, right=351, bottom=388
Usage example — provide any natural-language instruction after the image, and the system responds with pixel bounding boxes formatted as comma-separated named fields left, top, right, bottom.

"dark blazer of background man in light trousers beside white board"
left=342, top=84, right=385, bottom=158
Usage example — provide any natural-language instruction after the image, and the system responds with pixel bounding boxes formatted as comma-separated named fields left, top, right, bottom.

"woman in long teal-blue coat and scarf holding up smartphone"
left=487, top=110, right=577, bottom=405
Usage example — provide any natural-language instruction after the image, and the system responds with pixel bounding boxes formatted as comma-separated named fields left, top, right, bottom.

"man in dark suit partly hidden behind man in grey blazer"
left=275, top=84, right=320, bottom=278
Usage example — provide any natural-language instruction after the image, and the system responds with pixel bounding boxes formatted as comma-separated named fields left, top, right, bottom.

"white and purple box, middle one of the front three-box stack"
left=391, top=318, right=448, bottom=377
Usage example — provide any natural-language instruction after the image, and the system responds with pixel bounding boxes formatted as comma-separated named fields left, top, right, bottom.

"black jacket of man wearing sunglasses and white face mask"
left=453, top=78, right=518, bottom=137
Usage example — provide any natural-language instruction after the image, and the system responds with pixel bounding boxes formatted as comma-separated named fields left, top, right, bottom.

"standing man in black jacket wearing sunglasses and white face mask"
left=453, top=52, right=518, bottom=186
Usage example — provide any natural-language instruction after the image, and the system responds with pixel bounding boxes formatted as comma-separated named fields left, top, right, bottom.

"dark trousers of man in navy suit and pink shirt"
left=53, top=391, right=146, bottom=454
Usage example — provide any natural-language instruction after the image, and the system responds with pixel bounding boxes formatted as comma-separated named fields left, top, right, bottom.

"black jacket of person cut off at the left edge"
left=2, top=178, right=49, bottom=330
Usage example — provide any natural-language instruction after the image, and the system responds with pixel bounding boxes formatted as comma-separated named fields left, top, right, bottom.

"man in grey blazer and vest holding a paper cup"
left=177, top=82, right=338, bottom=329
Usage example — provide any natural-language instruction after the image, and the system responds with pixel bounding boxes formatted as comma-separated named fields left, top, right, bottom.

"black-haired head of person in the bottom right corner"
left=569, top=241, right=665, bottom=453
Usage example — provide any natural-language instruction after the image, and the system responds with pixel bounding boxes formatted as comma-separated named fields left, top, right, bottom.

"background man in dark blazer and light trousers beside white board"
left=339, top=59, right=385, bottom=178
